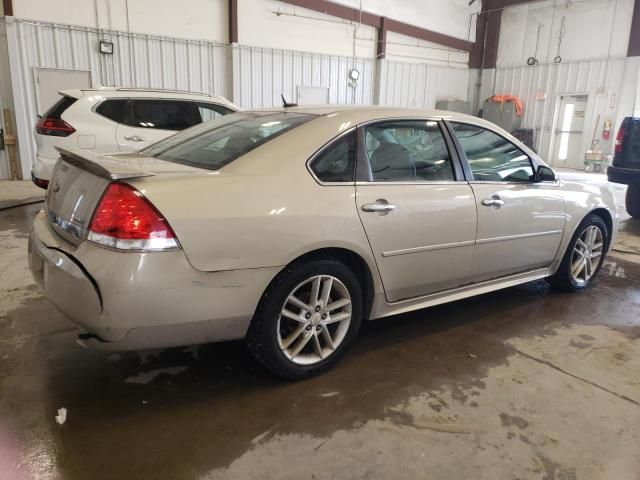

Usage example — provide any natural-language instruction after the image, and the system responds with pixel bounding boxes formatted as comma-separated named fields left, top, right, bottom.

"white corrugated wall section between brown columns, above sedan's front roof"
left=379, top=60, right=469, bottom=108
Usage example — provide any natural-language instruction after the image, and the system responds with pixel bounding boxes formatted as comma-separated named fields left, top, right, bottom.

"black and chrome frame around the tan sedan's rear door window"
left=356, top=117, right=467, bottom=185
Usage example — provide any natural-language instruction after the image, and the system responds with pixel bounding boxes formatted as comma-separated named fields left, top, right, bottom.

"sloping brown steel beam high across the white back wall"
left=281, top=0, right=472, bottom=53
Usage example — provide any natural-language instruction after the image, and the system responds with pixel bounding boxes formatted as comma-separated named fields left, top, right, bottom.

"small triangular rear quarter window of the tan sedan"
left=310, top=132, right=356, bottom=182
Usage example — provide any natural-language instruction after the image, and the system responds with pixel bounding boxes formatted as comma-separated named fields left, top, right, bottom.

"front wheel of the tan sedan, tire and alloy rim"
left=548, top=214, right=609, bottom=292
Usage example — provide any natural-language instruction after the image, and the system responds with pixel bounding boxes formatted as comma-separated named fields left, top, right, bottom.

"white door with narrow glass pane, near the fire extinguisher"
left=553, top=95, right=588, bottom=169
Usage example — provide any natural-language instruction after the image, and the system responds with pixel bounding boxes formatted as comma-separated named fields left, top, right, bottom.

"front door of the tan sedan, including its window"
left=451, top=122, right=565, bottom=282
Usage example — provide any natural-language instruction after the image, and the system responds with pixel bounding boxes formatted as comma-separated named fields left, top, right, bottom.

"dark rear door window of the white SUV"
left=128, top=100, right=199, bottom=130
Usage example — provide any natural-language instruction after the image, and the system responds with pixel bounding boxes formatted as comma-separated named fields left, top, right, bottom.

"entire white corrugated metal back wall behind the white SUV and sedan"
left=7, top=19, right=476, bottom=176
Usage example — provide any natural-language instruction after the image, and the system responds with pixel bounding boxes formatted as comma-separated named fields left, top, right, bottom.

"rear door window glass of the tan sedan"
left=364, top=121, right=455, bottom=182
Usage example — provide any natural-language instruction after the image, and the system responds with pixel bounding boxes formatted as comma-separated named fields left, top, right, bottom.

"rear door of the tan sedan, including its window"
left=356, top=120, right=476, bottom=302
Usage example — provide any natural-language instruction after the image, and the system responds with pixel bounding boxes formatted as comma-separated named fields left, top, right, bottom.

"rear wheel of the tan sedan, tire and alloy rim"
left=246, top=258, right=362, bottom=380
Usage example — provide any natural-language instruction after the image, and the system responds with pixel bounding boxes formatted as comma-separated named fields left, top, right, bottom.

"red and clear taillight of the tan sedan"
left=87, top=183, right=178, bottom=250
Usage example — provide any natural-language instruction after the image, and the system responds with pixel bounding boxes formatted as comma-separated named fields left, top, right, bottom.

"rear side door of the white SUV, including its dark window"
left=116, top=98, right=195, bottom=152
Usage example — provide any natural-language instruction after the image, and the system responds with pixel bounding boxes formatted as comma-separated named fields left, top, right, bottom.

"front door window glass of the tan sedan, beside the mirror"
left=451, top=123, right=534, bottom=182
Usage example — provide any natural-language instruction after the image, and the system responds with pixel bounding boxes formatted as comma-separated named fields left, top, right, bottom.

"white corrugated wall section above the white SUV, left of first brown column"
left=7, top=19, right=229, bottom=176
